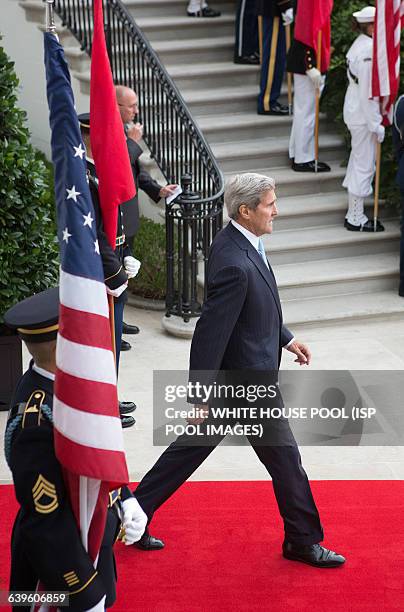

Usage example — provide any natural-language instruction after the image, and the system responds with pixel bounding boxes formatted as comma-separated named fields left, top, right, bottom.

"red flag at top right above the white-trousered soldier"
left=294, top=0, right=333, bottom=72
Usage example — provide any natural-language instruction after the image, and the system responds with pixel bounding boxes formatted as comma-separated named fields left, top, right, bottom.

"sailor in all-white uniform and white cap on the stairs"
left=343, top=6, right=384, bottom=232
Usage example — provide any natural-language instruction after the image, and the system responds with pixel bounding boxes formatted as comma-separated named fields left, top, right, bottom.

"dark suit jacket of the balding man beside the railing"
left=121, top=138, right=161, bottom=236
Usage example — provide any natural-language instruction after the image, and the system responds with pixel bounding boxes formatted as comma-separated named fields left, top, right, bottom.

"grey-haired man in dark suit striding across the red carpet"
left=135, top=173, right=345, bottom=567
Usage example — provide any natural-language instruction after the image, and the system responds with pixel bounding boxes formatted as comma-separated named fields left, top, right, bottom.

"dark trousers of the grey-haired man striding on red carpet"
left=134, top=418, right=323, bottom=545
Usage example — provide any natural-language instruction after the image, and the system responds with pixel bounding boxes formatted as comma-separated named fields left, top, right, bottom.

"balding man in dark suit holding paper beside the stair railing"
left=115, top=85, right=177, bottom=350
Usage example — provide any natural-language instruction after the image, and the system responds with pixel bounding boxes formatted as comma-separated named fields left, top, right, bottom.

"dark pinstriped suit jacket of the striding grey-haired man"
left=190, top=223, right=293, bottom=378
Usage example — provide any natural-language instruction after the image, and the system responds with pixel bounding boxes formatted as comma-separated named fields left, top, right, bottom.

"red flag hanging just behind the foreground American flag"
left=90, top=0, right=136, bottom=249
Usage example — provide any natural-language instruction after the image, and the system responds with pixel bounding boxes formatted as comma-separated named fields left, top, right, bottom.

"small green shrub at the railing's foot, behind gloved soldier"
left=129, top=217, right=166, bottom=300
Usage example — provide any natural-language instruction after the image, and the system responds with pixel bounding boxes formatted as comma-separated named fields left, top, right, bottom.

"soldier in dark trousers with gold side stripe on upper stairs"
left=257, top=0, right=293, bottom=115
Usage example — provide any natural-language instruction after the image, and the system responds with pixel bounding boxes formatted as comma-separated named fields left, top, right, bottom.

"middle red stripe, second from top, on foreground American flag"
left=55, top=369, right=119, bottom=416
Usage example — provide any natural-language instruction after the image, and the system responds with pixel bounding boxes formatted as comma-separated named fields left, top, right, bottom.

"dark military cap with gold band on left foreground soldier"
left=4, top=287, right=59, bottom=342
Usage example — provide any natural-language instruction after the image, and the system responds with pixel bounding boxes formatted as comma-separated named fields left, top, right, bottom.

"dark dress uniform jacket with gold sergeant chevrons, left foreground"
left=6, top=362, right=131, bottom=612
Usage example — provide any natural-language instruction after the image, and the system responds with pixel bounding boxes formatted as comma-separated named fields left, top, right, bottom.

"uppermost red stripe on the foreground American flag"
left=59, top=304, right=112, bottom=351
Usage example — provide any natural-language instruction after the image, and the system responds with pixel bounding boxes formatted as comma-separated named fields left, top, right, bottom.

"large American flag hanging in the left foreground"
left=44, top=32, right=128, bottom=561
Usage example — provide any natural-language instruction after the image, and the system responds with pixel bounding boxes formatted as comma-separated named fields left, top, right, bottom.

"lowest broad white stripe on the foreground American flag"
left=54, top=395, right=124, bottom=451
